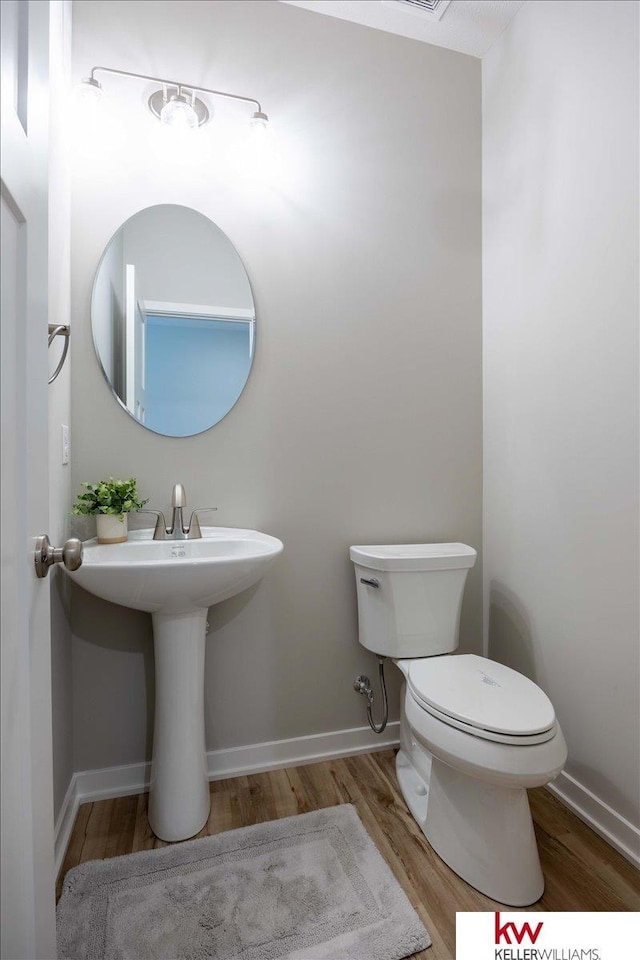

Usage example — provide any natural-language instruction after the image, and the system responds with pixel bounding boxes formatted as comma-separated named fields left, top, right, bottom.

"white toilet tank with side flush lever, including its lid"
left=349, top=543, right=477, bottom=657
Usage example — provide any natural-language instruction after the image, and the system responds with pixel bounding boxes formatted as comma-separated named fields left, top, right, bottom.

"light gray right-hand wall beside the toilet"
left=482, top=2, right=640, bottom=823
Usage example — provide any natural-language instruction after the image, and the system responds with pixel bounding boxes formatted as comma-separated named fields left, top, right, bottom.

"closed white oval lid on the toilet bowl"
left=408, top=654, right=555, bottom=739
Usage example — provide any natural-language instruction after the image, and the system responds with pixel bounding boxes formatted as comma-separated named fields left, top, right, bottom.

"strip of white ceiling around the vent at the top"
left=282, top=0, right=524, bottom=57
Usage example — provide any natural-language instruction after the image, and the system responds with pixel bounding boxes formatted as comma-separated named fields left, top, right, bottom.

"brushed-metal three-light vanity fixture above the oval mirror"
left=78, top=67, right=269, bottom=130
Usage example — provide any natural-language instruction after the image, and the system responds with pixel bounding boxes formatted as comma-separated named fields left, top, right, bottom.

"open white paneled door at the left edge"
left=0, top=0, right=56, bottom=960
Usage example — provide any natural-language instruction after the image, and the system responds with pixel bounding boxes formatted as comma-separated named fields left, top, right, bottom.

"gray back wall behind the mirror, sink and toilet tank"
left=72, top=0, right=482, bottom=769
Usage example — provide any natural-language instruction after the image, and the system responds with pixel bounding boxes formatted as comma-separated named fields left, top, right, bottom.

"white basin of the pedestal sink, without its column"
left=67, top=527, right=283, bottom=613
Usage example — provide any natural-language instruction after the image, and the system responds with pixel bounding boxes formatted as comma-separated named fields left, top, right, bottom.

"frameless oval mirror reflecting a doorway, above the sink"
left=91, top=204, right=255, bottom=437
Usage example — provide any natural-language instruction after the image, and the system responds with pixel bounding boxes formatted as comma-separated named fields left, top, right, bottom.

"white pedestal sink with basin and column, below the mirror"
left=66, top=527, right=283, bottom=840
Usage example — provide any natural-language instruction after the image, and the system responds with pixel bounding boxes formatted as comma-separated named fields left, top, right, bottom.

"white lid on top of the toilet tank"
left=349, top=543, right=477, bottom=570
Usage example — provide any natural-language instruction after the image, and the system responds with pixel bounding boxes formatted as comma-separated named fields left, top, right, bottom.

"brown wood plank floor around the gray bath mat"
left=58, top=750, right=640, bottom=960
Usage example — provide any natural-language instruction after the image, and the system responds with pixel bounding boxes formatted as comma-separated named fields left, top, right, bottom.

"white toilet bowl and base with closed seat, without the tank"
left=396, top=655, right=567, bottom=906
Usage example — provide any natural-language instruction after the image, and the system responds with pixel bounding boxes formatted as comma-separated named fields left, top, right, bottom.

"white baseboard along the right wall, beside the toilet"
left=547, top=773, right=640, bottom=869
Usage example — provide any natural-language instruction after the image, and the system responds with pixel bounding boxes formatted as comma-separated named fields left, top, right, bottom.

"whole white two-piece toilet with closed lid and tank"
left=350, top=543, right=567, bottom=907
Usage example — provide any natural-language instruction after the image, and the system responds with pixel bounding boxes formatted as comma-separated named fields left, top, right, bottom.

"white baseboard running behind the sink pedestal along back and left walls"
left=55, top=720, right=400, bottom=875
